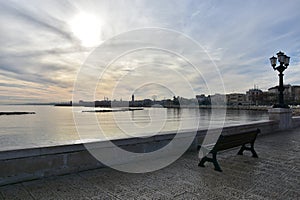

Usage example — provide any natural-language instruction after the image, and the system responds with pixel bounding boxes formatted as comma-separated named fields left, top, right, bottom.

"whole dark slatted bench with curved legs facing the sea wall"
left=198, top=129, right=260, bottom=172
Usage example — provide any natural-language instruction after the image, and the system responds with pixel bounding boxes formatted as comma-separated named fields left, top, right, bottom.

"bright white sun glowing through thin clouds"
left=70, top=13, right=102, bottom=47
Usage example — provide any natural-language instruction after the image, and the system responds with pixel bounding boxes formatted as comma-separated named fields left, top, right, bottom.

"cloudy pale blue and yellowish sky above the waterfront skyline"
left=0, top=0, right=300, bottom=103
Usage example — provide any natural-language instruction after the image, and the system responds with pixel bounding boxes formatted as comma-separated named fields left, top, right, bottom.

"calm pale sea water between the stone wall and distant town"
left=0, top=106, right=268, bottom=150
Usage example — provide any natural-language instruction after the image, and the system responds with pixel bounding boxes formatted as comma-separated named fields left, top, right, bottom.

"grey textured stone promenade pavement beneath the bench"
left=0, top=128, right=300, bottom=199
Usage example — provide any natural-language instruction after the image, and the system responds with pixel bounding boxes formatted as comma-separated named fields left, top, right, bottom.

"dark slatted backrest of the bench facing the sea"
left=212, top=129, right=260, bottom=151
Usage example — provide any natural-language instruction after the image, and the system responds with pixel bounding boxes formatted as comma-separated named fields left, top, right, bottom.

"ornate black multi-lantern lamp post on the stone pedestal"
left=270, top=51, right=290, bottom=108
